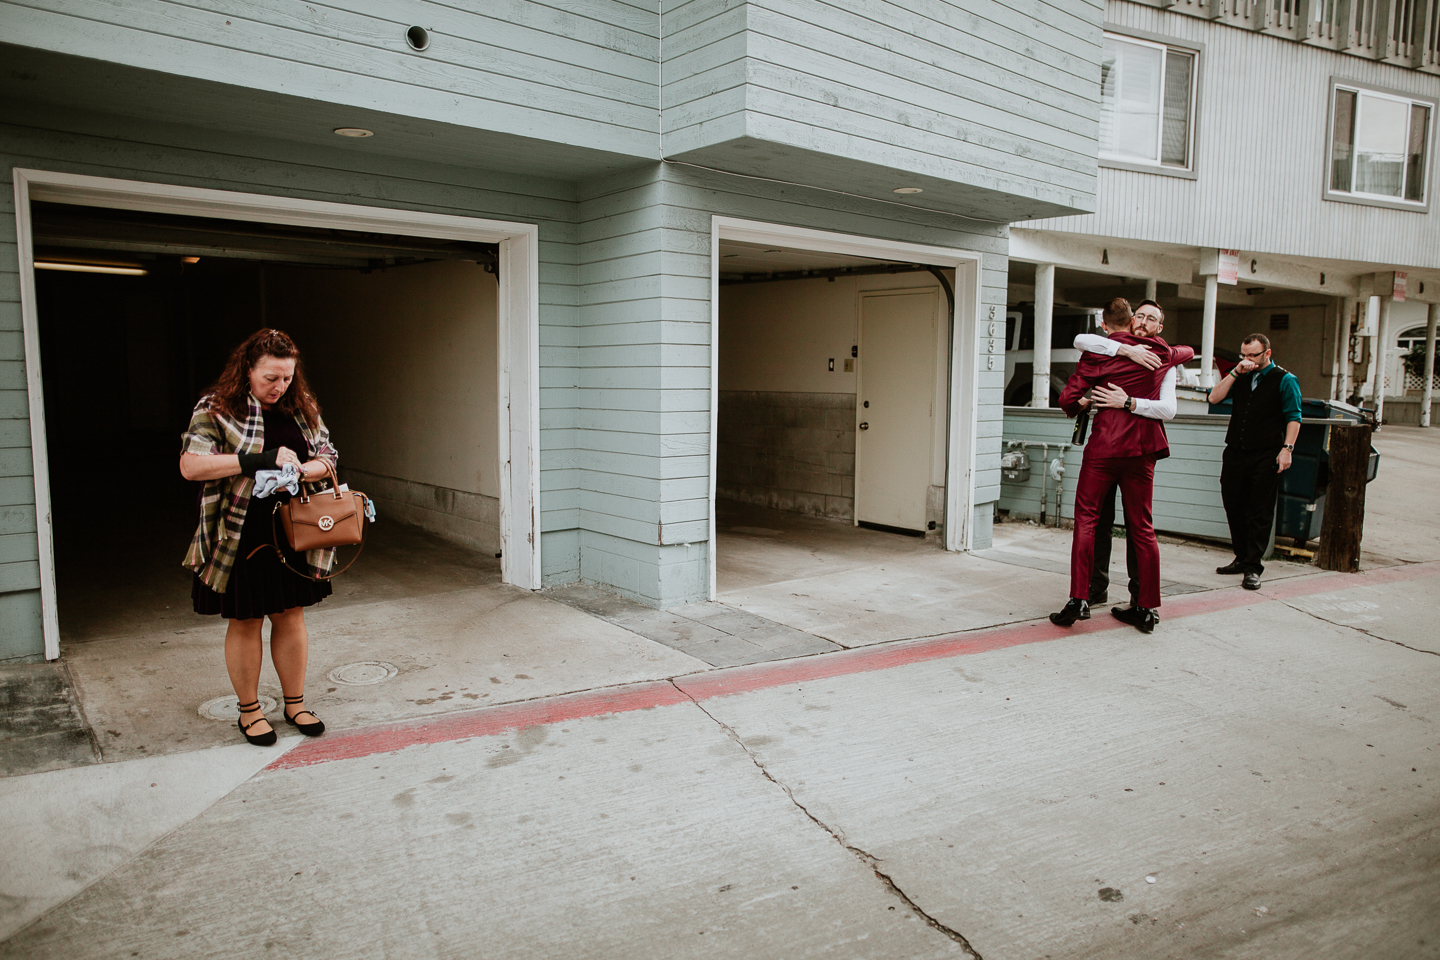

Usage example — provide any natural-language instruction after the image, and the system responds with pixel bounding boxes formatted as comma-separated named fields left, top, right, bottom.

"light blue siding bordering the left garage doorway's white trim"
left=0, top=109, right=579, bottom=659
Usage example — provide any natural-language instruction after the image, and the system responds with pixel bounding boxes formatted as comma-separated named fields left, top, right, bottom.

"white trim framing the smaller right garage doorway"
left=707, top=216, right=982, bottom=600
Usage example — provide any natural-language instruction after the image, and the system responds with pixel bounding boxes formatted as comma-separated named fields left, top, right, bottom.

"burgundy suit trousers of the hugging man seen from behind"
left=1070, top=456, right=1161, bottom=610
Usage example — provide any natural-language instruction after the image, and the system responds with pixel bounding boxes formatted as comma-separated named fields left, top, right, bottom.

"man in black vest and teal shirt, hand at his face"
left=1210, top=334, right=1300, bottom=590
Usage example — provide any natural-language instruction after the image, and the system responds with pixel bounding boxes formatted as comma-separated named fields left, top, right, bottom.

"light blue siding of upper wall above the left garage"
left=0, top=0, right=660, bottom=158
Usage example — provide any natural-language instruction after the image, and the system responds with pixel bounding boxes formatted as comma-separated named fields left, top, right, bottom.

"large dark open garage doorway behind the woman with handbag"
left=12, top=170, right=536, bottom=659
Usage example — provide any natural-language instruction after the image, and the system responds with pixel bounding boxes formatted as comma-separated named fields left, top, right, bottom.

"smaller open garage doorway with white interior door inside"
left=711, top=219, right=978, bottom=599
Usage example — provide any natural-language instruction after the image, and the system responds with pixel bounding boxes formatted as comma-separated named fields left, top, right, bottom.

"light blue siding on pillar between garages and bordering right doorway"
left=576, top=164, right=1005, bottom=606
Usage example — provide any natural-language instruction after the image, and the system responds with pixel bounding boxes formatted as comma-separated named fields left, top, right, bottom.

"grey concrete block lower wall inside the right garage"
left=716, top=390, right=855, bottom=520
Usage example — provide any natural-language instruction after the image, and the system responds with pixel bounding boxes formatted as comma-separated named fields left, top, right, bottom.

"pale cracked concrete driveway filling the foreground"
left=0, top=429, right=1440, bottom=960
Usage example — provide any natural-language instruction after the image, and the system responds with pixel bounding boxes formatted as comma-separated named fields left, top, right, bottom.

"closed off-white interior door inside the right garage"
left=855, top=289, right=937, bottom=530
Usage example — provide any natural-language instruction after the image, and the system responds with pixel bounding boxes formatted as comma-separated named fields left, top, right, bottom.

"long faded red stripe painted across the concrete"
left=265, top=561, right=1440, bottom=770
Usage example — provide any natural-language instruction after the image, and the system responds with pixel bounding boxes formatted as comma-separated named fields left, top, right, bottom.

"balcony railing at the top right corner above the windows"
left=1153, top=0, right=1440, bottom=73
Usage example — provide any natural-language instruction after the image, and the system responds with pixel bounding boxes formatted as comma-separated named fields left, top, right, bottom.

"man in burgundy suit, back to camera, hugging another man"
left=1050, top=312, right=1195, bottom=633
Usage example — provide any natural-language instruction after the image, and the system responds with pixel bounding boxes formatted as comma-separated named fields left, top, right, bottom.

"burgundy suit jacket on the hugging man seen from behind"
left=1060, top=334, right=1195, bottom=461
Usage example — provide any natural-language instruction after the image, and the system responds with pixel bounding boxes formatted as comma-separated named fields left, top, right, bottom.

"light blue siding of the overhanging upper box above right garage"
left=662, top=0, right=1102, bottom=219
